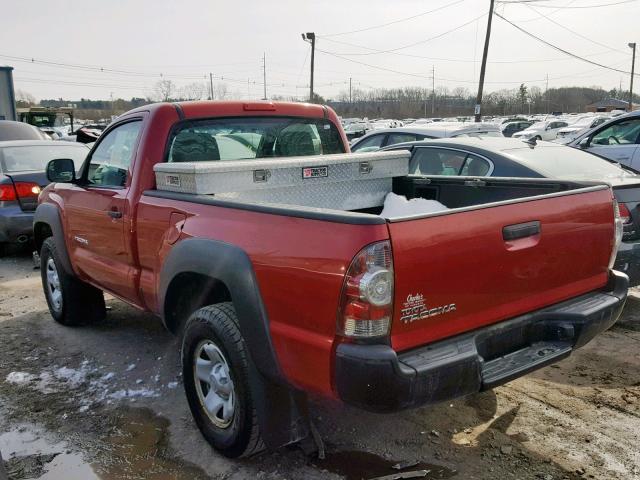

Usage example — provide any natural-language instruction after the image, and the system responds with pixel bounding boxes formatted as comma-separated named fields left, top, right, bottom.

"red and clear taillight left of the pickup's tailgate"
left=338, top=241, right=393, bottom=339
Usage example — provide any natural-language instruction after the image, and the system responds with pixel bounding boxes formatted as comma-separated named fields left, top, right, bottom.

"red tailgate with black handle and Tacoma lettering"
left=388, top=187, right=614, bottom=351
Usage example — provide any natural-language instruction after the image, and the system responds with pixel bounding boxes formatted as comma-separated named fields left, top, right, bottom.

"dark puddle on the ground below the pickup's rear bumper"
left=314, top=451, right=457, bottom=480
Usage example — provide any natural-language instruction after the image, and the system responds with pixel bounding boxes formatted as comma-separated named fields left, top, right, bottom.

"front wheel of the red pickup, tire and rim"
left=40, top=237, right=106, bottom=327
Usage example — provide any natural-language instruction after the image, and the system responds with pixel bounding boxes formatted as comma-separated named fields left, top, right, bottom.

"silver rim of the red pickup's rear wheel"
left=193, top=340, right=236, bottom=428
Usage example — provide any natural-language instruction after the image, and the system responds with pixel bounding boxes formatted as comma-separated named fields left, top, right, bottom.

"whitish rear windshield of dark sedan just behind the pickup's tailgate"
left=504, top=145, right=640, bottom=181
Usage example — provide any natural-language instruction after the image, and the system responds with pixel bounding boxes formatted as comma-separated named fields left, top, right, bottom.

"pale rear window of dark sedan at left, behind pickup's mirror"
left=0, top=142, right=89, bottom=173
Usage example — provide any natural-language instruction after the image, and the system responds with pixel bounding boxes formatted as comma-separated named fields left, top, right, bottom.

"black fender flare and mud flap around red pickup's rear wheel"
left=158, top=238, right=309, bottom=449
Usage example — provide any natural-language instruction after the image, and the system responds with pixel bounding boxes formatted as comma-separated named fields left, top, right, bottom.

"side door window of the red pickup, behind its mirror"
left=87, top=120, right=142, bottom=187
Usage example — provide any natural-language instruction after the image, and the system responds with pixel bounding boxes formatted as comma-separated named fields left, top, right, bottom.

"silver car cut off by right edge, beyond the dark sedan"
left=567, top=111, right=640, bottom=170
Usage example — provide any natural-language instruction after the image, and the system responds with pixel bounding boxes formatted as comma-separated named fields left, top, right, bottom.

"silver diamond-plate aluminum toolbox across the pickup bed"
left=154, top=150, right=410, bottom=210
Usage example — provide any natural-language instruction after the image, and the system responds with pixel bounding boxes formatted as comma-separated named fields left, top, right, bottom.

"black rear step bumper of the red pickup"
left=335, top=271, right=628, bottom=412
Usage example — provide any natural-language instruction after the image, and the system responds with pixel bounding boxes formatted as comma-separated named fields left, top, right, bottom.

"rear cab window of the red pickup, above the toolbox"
left=167, top=117, right=345, bottom=162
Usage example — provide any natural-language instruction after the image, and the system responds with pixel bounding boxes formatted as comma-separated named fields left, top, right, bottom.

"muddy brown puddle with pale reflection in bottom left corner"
left=0, top=409, right=208, bottom=480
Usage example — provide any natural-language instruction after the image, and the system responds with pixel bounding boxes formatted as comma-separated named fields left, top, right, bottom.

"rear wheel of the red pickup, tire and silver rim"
left=182, top=303, right=264, bottom=458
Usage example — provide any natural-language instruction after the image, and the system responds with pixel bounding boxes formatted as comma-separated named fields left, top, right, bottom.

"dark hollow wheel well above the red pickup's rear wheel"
left=164, top=272, right=231, bottom=333
